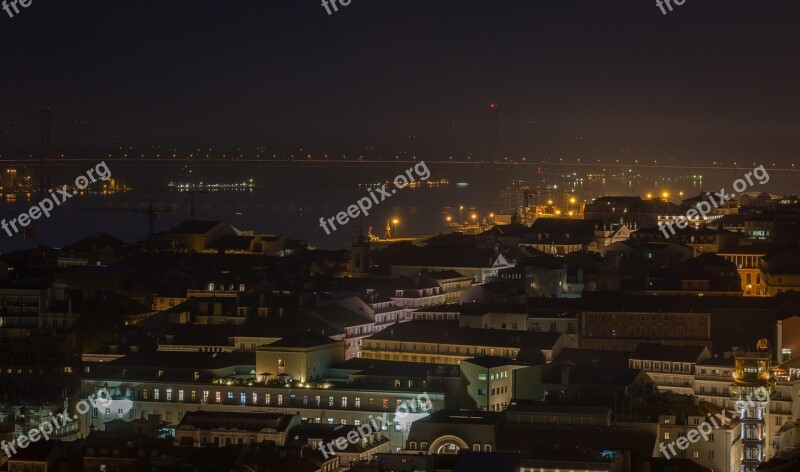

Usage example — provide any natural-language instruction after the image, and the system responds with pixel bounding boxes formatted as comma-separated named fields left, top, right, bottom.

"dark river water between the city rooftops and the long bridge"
left=0, top=162, right=796, bottom=252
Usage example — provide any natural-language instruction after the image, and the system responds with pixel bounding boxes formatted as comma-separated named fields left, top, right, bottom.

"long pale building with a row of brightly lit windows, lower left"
left=77, top=351, right=446, bottom=454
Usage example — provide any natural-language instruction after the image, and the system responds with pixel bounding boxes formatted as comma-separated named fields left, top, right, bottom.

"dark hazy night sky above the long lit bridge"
left=0, top=0, right=800, bottom=163
